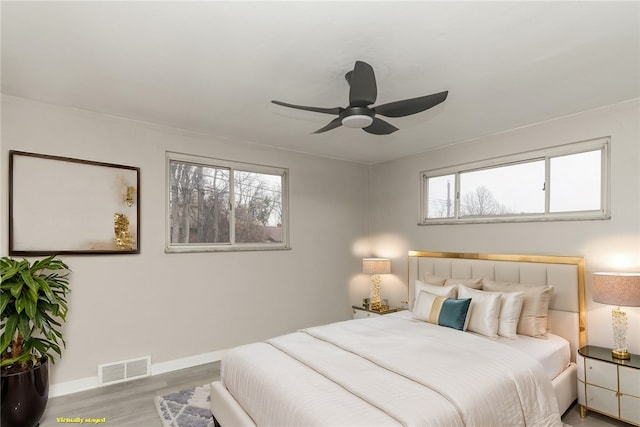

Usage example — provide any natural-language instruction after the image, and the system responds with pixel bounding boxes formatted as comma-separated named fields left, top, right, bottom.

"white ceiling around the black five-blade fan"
left=1, top=1, right=640, bottom=164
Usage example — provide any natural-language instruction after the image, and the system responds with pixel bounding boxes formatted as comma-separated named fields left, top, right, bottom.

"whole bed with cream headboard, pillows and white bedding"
left=211, top=251, right=586, bottom=427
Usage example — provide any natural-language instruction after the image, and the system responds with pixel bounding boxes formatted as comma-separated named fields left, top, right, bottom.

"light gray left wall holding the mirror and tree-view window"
left=0, top=96, right=368, bottom=391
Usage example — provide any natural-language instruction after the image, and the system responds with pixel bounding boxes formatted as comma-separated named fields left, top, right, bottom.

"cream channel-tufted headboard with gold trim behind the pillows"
left=407, top=251, right=587, bottom=360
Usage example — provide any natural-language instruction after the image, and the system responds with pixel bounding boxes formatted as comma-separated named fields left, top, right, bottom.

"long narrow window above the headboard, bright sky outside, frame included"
left=420, top=138, right=610, bottom=224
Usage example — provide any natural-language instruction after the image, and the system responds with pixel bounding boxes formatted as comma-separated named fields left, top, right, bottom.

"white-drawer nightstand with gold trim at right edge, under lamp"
left=576, top=345, right=640, bottom=426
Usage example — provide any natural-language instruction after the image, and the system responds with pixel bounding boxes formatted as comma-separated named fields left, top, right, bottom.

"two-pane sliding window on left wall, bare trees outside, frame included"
left=166, top=153, right=288, bottom=252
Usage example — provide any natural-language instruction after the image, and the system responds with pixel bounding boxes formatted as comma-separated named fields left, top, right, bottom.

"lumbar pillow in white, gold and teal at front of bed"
left=413, top=291, right=471, bottom=331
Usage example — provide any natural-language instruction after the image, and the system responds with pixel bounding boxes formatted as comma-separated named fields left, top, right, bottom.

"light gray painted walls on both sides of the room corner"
left=0, top=96, right=640, bottom=391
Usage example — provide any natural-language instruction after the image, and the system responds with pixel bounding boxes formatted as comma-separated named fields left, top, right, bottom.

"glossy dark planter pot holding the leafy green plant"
left=0, top=358, right=49, bottom=427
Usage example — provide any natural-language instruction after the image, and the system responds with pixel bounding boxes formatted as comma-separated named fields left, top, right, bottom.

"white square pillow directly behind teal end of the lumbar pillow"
left=458, top=285, right=501, bottom=338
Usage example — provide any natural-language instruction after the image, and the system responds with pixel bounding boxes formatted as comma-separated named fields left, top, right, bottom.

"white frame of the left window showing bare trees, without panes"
left=165, top=151, right=291, bottom=253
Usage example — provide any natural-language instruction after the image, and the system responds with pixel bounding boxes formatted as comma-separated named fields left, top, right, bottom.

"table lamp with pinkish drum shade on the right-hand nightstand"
left=591, top=273, right=640, bottom=360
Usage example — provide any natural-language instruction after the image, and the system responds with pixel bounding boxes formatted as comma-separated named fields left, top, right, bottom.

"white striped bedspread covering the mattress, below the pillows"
left=221, top=315, right=562, bottom=426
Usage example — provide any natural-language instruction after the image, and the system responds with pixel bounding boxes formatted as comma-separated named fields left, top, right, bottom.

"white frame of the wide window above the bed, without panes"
left=418, top=137, right=611, bottom=225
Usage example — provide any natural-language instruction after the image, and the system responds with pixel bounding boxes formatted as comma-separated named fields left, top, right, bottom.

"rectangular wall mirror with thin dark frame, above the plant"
left=9, top=150, right=140, bottom=256
